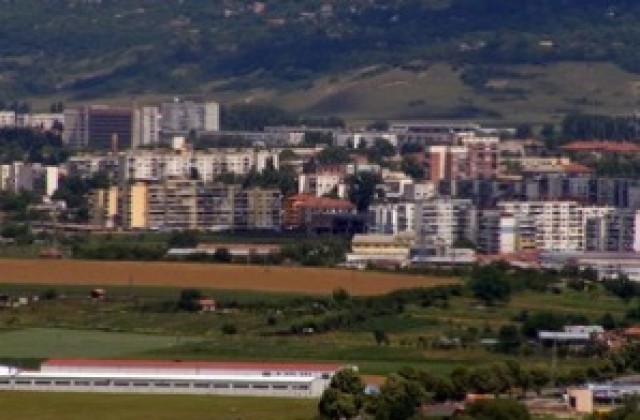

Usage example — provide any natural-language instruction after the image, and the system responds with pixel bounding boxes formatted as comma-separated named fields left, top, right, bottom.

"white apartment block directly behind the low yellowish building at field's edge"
left=369, top=202, right=416, bottom=235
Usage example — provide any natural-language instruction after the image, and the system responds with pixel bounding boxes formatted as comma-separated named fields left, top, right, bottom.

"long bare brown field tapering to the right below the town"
left=0, top=260, right=456, bottom=295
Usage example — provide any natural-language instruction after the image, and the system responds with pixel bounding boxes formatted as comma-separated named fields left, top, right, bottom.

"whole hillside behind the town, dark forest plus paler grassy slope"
left=6, top=0, right=640, bottom=118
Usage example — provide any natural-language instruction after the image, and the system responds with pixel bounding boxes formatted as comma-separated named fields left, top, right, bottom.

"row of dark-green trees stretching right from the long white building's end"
left=318, top=362, right=536, bottom=420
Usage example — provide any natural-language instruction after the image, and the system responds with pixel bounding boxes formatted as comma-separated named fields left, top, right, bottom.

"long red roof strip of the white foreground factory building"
left=42, top=359, right=344, bottom=372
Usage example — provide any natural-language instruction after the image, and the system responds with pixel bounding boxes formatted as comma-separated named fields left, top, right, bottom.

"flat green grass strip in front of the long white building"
left=0, top=392, right=317, bottom=420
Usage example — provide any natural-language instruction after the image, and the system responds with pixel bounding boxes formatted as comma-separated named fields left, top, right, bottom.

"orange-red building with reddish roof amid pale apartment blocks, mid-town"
left=283, top=194, right=356, bottom=229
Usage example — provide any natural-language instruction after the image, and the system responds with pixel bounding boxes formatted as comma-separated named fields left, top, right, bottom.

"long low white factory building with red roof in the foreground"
left=0, top=360, right=345, bottom=398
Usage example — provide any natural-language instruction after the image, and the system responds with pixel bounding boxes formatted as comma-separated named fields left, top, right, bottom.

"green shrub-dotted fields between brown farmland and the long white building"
left=0, top=276, right=635, bottom=375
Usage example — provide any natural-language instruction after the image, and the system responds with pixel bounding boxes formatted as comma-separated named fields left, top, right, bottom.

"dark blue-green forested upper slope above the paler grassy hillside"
left=6, top=0, right=640, bottom=100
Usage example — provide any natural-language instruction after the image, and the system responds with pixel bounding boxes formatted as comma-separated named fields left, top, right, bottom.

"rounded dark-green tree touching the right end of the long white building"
left=318, top=369, right=364, bottom=419
